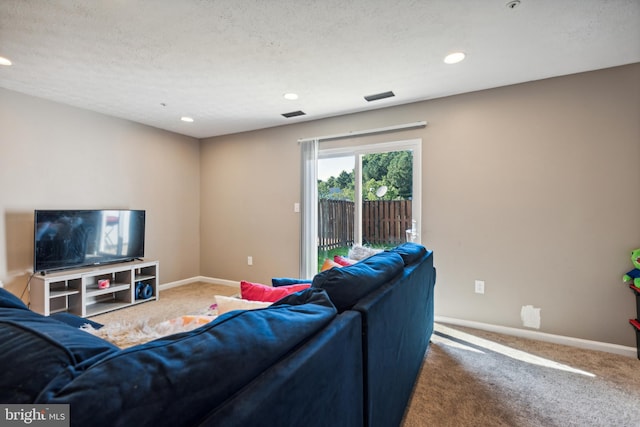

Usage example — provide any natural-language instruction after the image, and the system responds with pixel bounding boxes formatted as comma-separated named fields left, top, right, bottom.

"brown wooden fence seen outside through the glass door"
left=318, top=199, right=411, bottom=250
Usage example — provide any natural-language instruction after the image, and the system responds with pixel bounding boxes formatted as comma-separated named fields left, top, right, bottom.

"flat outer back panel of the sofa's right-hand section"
left=353, top=253, right=436, bottom=426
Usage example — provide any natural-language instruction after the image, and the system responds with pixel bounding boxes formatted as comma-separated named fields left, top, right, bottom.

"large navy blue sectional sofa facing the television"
left=0, top=244, right=435, bottom=427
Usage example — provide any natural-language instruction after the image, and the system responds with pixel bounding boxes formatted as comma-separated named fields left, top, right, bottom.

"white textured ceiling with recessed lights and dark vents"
left=0, top=0, right=640, bottom=138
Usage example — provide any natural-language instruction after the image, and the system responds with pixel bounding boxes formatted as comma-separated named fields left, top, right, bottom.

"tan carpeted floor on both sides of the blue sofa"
left=91, top=283, right=640, bottom=427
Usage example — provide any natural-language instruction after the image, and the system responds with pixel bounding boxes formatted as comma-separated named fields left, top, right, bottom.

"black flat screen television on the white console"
left=33, top=210, right=146, bottom=273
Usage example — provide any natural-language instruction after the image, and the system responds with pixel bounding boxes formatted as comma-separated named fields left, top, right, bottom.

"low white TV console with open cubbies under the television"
left=29, top=261, right=159, bottom=317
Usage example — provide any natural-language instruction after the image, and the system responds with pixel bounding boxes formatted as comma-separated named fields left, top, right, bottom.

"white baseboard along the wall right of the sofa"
left=435, top=316, right=638, bottom=358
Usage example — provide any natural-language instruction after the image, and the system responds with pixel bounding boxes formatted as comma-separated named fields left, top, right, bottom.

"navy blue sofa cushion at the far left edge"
left=0, top=307, right=118, bottom=403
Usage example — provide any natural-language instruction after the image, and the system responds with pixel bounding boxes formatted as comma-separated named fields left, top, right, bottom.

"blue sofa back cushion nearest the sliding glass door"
left=312, top=252, right=404, bottom=312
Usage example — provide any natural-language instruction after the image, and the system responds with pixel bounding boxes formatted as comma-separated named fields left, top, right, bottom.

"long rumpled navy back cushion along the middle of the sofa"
left=40, top=289, right=336, bottom=427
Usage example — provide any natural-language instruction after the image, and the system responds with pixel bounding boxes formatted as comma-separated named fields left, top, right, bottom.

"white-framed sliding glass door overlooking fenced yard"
left=316, top=140, right=421, bottom=269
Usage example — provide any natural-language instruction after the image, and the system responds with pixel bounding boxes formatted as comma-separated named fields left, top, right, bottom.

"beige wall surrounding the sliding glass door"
left=201, top=64, right=640, bottom=346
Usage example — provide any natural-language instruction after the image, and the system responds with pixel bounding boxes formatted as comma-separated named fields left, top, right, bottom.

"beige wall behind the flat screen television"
left=0, top=89, right=200, bottom=300
